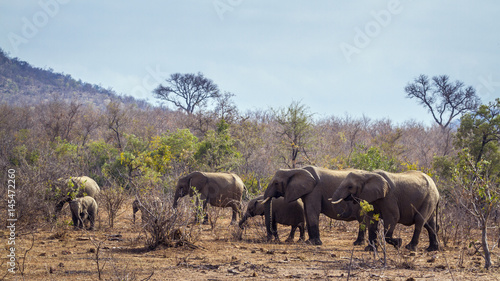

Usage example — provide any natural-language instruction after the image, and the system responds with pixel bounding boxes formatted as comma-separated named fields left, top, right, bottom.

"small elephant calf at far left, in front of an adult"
left=69, top=196, right=98, bottom=230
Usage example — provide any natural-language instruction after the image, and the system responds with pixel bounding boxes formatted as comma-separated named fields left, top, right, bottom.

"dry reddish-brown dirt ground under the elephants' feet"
left=0, top=197, right=500, bottom=281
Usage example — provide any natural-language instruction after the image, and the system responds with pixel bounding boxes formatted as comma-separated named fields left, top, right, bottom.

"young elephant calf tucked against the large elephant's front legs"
left=239, top=196, right=305, bottom=242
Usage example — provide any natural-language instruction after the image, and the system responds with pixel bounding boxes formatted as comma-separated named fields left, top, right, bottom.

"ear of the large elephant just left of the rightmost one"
left=283, top=169, right=316, bottom=203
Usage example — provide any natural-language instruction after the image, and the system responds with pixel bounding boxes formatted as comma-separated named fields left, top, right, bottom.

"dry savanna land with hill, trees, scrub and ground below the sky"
left=0, top=49, right=500, bottom=280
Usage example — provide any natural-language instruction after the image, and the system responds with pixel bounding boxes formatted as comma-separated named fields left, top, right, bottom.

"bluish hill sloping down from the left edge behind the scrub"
left=0, top=49, right=149, bottom=108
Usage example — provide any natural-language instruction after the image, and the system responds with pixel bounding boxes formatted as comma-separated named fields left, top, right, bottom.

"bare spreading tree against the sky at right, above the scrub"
left=405, top=74, right=480, bottom=129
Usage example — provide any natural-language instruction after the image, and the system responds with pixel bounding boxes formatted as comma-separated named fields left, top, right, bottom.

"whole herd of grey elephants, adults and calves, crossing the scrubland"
left=56, top=166, right=439, bottom=251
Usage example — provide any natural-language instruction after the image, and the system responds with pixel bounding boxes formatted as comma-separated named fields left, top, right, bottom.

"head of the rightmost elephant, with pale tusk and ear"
left=331, top=172, right=390, bottom=204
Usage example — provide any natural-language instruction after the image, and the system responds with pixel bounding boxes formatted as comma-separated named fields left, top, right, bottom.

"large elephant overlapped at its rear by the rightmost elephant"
left=264, top=166, right=366, bottom=245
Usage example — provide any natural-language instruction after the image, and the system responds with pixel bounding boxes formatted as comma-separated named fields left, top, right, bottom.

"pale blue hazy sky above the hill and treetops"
left=0, top=0, right=500, bottom=125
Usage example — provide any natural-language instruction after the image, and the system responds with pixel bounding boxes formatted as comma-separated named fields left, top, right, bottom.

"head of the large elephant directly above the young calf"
left=264, top=169, right=316, bottom=203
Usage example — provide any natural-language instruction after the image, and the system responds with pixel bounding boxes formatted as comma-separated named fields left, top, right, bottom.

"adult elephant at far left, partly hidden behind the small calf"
left=55, top=176, right=101, bottom=215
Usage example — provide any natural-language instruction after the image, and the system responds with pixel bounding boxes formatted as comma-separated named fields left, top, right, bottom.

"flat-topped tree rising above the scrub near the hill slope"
left=153, top=72, right=220, bottom=114
